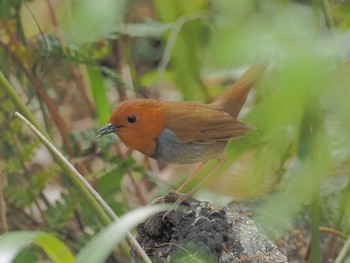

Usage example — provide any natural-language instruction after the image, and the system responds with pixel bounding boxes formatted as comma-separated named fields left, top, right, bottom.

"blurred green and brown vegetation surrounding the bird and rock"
left=0, top=0, right=350, bottom=263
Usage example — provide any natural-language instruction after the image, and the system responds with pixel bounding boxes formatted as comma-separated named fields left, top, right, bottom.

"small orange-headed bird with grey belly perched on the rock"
left=97, top=60, right=268, bottom=199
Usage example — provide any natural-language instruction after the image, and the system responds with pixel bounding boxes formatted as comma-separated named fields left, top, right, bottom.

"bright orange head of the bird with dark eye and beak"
left=97, top=99, right=164, bottom=156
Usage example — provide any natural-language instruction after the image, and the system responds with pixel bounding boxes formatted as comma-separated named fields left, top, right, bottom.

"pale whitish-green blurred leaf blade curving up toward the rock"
left=75, top=205, right=166, bottom=263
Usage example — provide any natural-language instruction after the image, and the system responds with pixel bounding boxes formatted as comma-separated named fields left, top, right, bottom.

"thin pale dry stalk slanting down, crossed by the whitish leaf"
left=15, top=112, right=152, bottom=263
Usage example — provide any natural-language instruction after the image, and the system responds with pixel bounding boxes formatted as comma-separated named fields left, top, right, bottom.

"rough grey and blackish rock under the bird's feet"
left=131, top=192, right=287, bottom=263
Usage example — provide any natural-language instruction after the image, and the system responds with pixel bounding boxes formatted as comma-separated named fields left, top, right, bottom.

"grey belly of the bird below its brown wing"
left=151, top=129, right=227, bottom=164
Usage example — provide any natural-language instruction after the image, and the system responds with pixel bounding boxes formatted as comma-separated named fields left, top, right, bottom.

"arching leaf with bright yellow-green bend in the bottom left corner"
left=0, top=231, right=74, bottom=263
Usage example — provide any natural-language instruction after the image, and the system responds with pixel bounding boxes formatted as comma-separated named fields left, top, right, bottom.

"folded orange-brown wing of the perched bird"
left=166, top=104, right=251, bottom=144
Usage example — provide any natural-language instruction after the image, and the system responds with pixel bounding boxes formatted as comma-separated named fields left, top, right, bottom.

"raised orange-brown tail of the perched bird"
left=211, top=60, right=269, bottom=118
